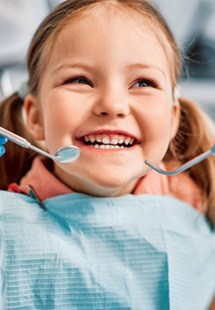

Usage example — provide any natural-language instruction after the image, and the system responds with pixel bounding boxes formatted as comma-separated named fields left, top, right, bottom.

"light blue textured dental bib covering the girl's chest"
left=0, top=191, right=215, bottom=310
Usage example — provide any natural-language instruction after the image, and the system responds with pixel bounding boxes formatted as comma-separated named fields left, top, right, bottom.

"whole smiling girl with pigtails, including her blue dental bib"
left=0, top=0, right=215, bottom=309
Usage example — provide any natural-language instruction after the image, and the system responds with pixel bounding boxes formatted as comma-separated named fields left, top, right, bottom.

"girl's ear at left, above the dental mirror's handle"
left=24, top=94, right=45, bottom=141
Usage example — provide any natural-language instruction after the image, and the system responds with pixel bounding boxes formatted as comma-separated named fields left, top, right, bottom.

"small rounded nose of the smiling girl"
left=93, top=88, right=130, bottom=118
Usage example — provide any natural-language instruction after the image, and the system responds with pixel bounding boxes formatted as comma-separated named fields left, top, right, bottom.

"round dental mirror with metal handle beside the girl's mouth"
left=0, top=127, right=80, bottom=163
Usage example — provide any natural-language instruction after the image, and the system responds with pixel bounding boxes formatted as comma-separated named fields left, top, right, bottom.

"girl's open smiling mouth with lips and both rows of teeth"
left=81, top=134, right=139, bottom=149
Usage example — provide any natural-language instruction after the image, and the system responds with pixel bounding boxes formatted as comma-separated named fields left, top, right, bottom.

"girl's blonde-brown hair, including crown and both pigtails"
left=0, top=0, right=215, bottom=223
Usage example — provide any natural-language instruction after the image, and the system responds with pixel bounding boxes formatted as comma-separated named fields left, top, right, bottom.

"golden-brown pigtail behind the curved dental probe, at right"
left=165, top=98, right=215, bottom=223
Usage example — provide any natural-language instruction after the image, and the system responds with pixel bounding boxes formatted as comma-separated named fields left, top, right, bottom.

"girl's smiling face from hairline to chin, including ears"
left=25, top=5, right=178, bottom=196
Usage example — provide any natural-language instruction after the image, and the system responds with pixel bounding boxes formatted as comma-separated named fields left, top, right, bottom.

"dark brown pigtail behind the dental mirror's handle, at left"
left=0, top=93, right=35, bottom=190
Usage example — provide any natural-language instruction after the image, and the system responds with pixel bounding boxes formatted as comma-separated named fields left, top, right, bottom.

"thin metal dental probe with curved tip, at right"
left=145, top=145, right=215, bottom=176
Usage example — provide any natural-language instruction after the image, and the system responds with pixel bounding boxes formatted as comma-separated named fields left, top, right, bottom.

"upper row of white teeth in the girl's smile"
left=84, top=135, right=134, bottom=145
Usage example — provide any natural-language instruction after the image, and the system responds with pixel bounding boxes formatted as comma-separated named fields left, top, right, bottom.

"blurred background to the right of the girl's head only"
left=152, top=0, right=215, bottom=120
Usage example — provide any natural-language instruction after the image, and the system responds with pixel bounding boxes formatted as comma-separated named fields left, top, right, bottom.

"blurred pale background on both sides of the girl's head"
left=0, top=0, right=215, bottom=120
